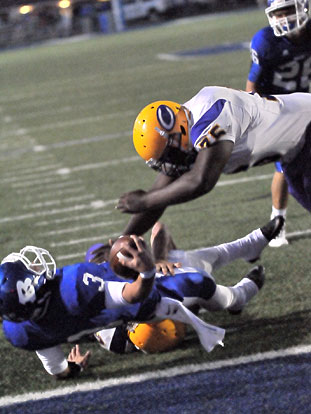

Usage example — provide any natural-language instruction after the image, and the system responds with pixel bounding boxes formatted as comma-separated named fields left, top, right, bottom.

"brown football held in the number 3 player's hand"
left=109, top=236, right=139, bottom=279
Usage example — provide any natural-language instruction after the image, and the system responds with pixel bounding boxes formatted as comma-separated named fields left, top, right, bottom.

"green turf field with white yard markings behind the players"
left=0, top=10, right=311, bottom=396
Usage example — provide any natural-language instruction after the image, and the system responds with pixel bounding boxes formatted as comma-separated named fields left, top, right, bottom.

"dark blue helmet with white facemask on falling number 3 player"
left=0, top=246, right=56, bottom=322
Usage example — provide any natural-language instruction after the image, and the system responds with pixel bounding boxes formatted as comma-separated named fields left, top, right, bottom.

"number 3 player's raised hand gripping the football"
left=119, top=235, right=155, bottom=273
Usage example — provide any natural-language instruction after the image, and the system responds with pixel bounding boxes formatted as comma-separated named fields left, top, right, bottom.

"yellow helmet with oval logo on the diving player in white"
left=133, top=101, right=195, bottom=176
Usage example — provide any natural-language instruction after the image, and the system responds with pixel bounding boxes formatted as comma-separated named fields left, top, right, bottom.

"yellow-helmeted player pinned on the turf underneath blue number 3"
left=86, top=218, right=283, bottom=353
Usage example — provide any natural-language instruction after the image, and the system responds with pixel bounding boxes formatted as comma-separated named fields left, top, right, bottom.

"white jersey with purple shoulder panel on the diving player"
left=184, top=86, right=311, bottom=174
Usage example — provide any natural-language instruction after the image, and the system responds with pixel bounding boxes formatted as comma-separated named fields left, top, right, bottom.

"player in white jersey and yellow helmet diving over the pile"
left=106, top=86, right=311, bottom=243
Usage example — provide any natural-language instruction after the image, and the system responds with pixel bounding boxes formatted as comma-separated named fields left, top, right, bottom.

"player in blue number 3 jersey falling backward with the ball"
left=0, top=218, right=283, bottom=378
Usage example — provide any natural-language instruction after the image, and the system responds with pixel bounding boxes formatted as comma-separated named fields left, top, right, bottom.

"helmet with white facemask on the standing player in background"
left=265, top=0, right=309, bottom=36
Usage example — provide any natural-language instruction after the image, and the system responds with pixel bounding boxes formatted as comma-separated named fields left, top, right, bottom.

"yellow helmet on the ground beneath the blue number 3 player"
left=129, top=319, right=186, bottom=354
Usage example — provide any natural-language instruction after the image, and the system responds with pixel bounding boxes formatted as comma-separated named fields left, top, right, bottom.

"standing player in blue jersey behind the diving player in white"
left=246, top=0, right=311, bottom=247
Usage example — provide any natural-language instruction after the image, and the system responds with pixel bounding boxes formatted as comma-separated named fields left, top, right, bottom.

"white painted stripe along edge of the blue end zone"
left=0, top=345, right=311, bottom=407
